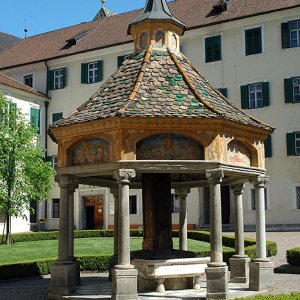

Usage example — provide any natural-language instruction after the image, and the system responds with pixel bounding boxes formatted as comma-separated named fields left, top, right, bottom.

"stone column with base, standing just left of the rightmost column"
left=229, top=183, right=250, bottom=283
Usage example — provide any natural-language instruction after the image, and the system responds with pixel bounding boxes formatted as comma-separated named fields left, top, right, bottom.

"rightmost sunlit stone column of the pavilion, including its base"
left=249, top=176, right=274, bottom=291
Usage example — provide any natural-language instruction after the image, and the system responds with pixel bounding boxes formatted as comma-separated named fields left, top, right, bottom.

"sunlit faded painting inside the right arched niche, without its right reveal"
left=228, top=140, right=251, bottom=167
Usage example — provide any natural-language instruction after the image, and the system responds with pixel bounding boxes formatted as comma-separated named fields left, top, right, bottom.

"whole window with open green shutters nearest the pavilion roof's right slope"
left=241, top=82, right=270, bottom=109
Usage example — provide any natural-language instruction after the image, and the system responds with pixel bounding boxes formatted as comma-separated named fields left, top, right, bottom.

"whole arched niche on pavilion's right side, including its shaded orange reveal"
left=227, top=139, right=257, bottom=167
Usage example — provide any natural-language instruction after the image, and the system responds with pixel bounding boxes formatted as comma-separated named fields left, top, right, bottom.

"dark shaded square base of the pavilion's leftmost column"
left=48, top=261, right=76, bottom=300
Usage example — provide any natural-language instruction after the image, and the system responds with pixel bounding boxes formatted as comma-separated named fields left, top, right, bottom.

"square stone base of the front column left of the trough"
left=111, top=267, right=138, bottom=300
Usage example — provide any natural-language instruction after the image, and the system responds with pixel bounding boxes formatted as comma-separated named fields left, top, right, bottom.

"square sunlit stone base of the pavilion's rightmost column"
left=249, top=259, right=274, bottom=291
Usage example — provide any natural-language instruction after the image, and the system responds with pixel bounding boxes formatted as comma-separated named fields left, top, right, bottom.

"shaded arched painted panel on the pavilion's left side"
left=67, top=137, right=110, bottom=166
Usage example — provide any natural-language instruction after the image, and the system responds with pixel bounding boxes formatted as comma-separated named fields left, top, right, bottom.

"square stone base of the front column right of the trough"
left=205, top=263, right=229, bottom=299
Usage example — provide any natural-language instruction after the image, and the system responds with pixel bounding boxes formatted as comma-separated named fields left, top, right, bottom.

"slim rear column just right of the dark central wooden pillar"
left=175, top=188, right=191, bottom=251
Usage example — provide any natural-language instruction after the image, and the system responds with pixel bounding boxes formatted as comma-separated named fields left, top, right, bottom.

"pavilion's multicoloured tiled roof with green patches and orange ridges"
left=52, top=46, right=273, bottom=131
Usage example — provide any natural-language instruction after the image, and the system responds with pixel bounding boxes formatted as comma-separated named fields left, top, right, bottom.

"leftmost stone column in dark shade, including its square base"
left=48, top=175, right=76, bottom=299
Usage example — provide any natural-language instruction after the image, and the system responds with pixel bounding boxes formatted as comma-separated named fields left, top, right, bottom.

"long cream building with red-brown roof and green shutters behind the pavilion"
left=0, top=0, right=300, bottom=230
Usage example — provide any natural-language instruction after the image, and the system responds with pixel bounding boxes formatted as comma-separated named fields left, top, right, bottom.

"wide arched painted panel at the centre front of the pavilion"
left=137, top=134, right=204, bottom=160
